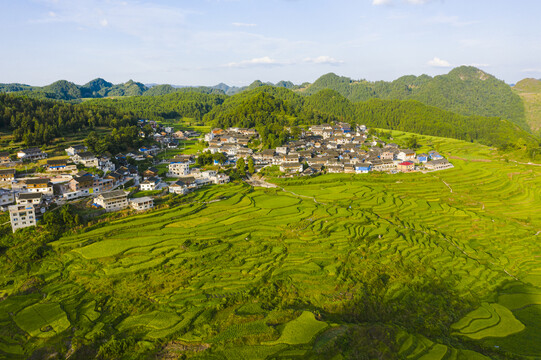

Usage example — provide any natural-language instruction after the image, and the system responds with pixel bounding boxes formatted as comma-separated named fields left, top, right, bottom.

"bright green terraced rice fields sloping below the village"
left=0, top=133, right=541, bottom=359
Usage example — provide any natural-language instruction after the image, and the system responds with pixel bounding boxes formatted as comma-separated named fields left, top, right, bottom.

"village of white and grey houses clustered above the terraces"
left=0, top=120, right=453, bottom=232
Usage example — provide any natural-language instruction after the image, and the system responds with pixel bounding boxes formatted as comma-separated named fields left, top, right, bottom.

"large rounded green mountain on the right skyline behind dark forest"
left=303, top=66, right=529, bottom=130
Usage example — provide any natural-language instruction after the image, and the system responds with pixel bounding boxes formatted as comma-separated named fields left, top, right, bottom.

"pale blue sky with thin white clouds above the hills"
left=0, top=0, right=541, bottom=86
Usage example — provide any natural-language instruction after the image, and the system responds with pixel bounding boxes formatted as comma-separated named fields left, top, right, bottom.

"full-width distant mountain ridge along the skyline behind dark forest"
left=0, top=66, right=541, bottom=131
